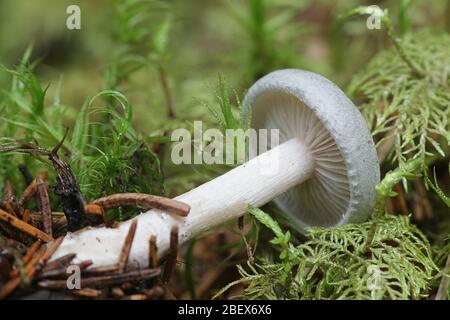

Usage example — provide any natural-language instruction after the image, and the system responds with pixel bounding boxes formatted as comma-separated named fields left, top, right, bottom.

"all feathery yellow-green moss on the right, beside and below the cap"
left=216, top=7, right=450, bottom=299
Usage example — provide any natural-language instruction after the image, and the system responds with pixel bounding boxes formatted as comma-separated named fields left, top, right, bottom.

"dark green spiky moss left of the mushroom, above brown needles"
left=0, top=53, right=163, bottom=220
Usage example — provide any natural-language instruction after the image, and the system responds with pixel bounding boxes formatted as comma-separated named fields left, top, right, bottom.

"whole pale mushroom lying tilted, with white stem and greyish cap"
left=53, top=69, right=380, bottom=267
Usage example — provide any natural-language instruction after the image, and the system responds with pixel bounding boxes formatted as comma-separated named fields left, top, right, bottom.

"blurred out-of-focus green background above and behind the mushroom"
left=0, top=0, right=449, bottom=198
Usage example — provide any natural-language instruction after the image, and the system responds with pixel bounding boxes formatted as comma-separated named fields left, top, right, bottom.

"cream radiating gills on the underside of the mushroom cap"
left=250, top=90, right=350, bottom=229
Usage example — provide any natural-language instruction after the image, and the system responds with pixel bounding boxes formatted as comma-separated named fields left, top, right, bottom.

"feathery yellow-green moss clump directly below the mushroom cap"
left=219, top=210, right=437, bottom=299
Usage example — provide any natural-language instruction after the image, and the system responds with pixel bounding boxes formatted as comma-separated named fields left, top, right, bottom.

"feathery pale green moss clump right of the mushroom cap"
left=349, top=31, right=450, bottom=166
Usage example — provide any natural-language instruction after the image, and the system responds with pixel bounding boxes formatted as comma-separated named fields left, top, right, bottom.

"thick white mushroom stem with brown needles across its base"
left=52, top=139, right=315, bottom=267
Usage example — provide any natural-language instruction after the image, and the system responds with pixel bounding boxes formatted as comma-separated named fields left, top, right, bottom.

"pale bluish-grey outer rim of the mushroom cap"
left=243, top=69, right=380, bottom=230
